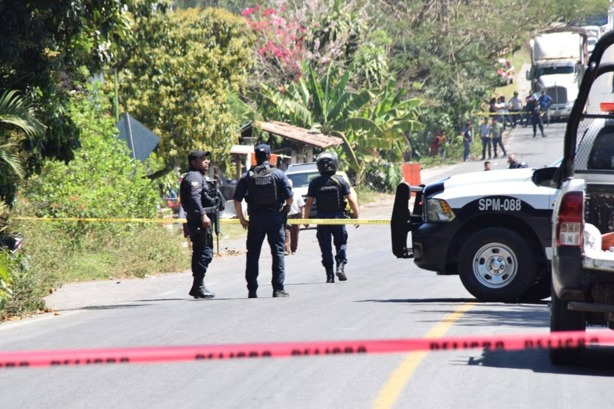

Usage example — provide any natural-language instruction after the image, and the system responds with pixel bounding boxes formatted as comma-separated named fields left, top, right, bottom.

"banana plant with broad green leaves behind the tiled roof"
left=261, top=66, right=421, bottom=183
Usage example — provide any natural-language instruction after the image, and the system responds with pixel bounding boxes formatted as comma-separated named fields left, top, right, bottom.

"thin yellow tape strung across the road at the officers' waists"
left=13, top=217, right=390, bottom=225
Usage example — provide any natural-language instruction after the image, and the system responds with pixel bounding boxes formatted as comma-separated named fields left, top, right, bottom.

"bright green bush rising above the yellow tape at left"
left=21, top=82, right=160, bottom=236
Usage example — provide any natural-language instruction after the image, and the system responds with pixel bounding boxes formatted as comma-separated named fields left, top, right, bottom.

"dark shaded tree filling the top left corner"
left=0, top=0, right=164, bottom=169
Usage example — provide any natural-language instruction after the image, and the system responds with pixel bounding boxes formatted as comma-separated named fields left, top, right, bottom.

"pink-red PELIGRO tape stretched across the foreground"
left=0, top=330, right=614, bottom=369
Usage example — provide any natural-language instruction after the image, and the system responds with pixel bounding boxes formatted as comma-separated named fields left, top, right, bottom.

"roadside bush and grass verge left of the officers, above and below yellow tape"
left=0, top=82, right=190, bottom=320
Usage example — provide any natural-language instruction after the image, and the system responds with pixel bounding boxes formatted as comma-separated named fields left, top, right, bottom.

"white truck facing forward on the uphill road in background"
left=527, top=27, right=588, bottom=119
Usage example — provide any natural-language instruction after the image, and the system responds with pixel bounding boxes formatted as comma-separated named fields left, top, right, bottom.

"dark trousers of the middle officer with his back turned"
left=245, top=210, right=286, bottom=291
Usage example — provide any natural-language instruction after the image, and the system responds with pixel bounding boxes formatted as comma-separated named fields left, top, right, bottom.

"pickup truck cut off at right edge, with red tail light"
left=550, top=31, right=614, bottom=364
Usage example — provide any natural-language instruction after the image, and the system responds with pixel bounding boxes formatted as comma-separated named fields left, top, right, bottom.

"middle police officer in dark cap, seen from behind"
left=233, top=144, right=293, bottom=298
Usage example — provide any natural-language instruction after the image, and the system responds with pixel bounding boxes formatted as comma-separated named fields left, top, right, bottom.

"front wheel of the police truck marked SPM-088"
left=458, top=227, right=538, bottom=302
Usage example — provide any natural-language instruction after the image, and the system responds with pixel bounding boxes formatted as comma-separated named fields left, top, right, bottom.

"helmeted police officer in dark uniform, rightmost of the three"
left=305, top=152, right=359, bottom=283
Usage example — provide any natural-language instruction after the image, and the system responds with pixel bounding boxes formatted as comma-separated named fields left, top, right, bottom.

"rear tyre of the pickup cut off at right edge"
left=550, top=290, right=586, bottom=365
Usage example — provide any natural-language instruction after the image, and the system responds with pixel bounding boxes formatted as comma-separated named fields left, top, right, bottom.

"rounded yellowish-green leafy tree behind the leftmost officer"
left=118, top=9, right=253, bottom=171
